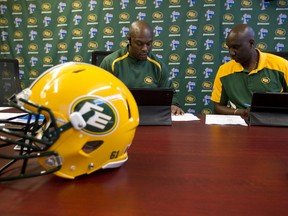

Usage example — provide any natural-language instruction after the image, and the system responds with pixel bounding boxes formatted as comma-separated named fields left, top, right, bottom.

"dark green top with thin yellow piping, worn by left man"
left=100, top=47, right=178, bottom=104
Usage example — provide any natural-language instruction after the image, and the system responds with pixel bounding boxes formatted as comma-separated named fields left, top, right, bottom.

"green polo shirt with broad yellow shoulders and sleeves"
left=211, top=50, right=288, bottom=108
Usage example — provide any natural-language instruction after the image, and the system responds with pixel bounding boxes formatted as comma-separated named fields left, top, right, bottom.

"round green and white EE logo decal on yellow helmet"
left=70, top=96, right=119, bottom=136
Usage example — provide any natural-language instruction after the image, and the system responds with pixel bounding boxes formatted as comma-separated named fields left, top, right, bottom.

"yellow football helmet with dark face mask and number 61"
left=0, top=62, right=139, bottom=180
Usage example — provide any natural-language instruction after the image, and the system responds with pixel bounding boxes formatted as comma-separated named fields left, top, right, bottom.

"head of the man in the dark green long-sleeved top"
left=127, top=20, right=153, bottom=60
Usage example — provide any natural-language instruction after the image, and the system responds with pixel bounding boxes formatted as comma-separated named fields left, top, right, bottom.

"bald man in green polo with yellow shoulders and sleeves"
left=211, top=24, right=288, bottom=117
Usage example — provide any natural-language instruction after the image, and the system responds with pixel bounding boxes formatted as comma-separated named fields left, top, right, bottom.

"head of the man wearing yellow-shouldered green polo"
left=226, top=24, right=256, bottom=65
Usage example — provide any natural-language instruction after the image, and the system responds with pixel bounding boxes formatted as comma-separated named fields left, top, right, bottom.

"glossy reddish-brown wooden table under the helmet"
left=0, top=115, right=288, bottom=216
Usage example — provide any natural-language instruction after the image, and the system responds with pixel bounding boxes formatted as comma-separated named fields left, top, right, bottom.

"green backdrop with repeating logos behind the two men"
left=0, top=0, right=288, bottom=113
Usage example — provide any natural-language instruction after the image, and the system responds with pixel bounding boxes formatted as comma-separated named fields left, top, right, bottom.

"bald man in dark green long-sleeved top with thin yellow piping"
left=100, top=20, right=184, bottom=115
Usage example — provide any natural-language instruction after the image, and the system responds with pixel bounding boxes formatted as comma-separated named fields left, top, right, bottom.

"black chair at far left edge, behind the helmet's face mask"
left=0, top=59, right=21, bottom=106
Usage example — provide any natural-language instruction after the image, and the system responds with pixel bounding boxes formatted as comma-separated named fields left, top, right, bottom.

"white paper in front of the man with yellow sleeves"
left=205, top=114, right=248, bottom=126
